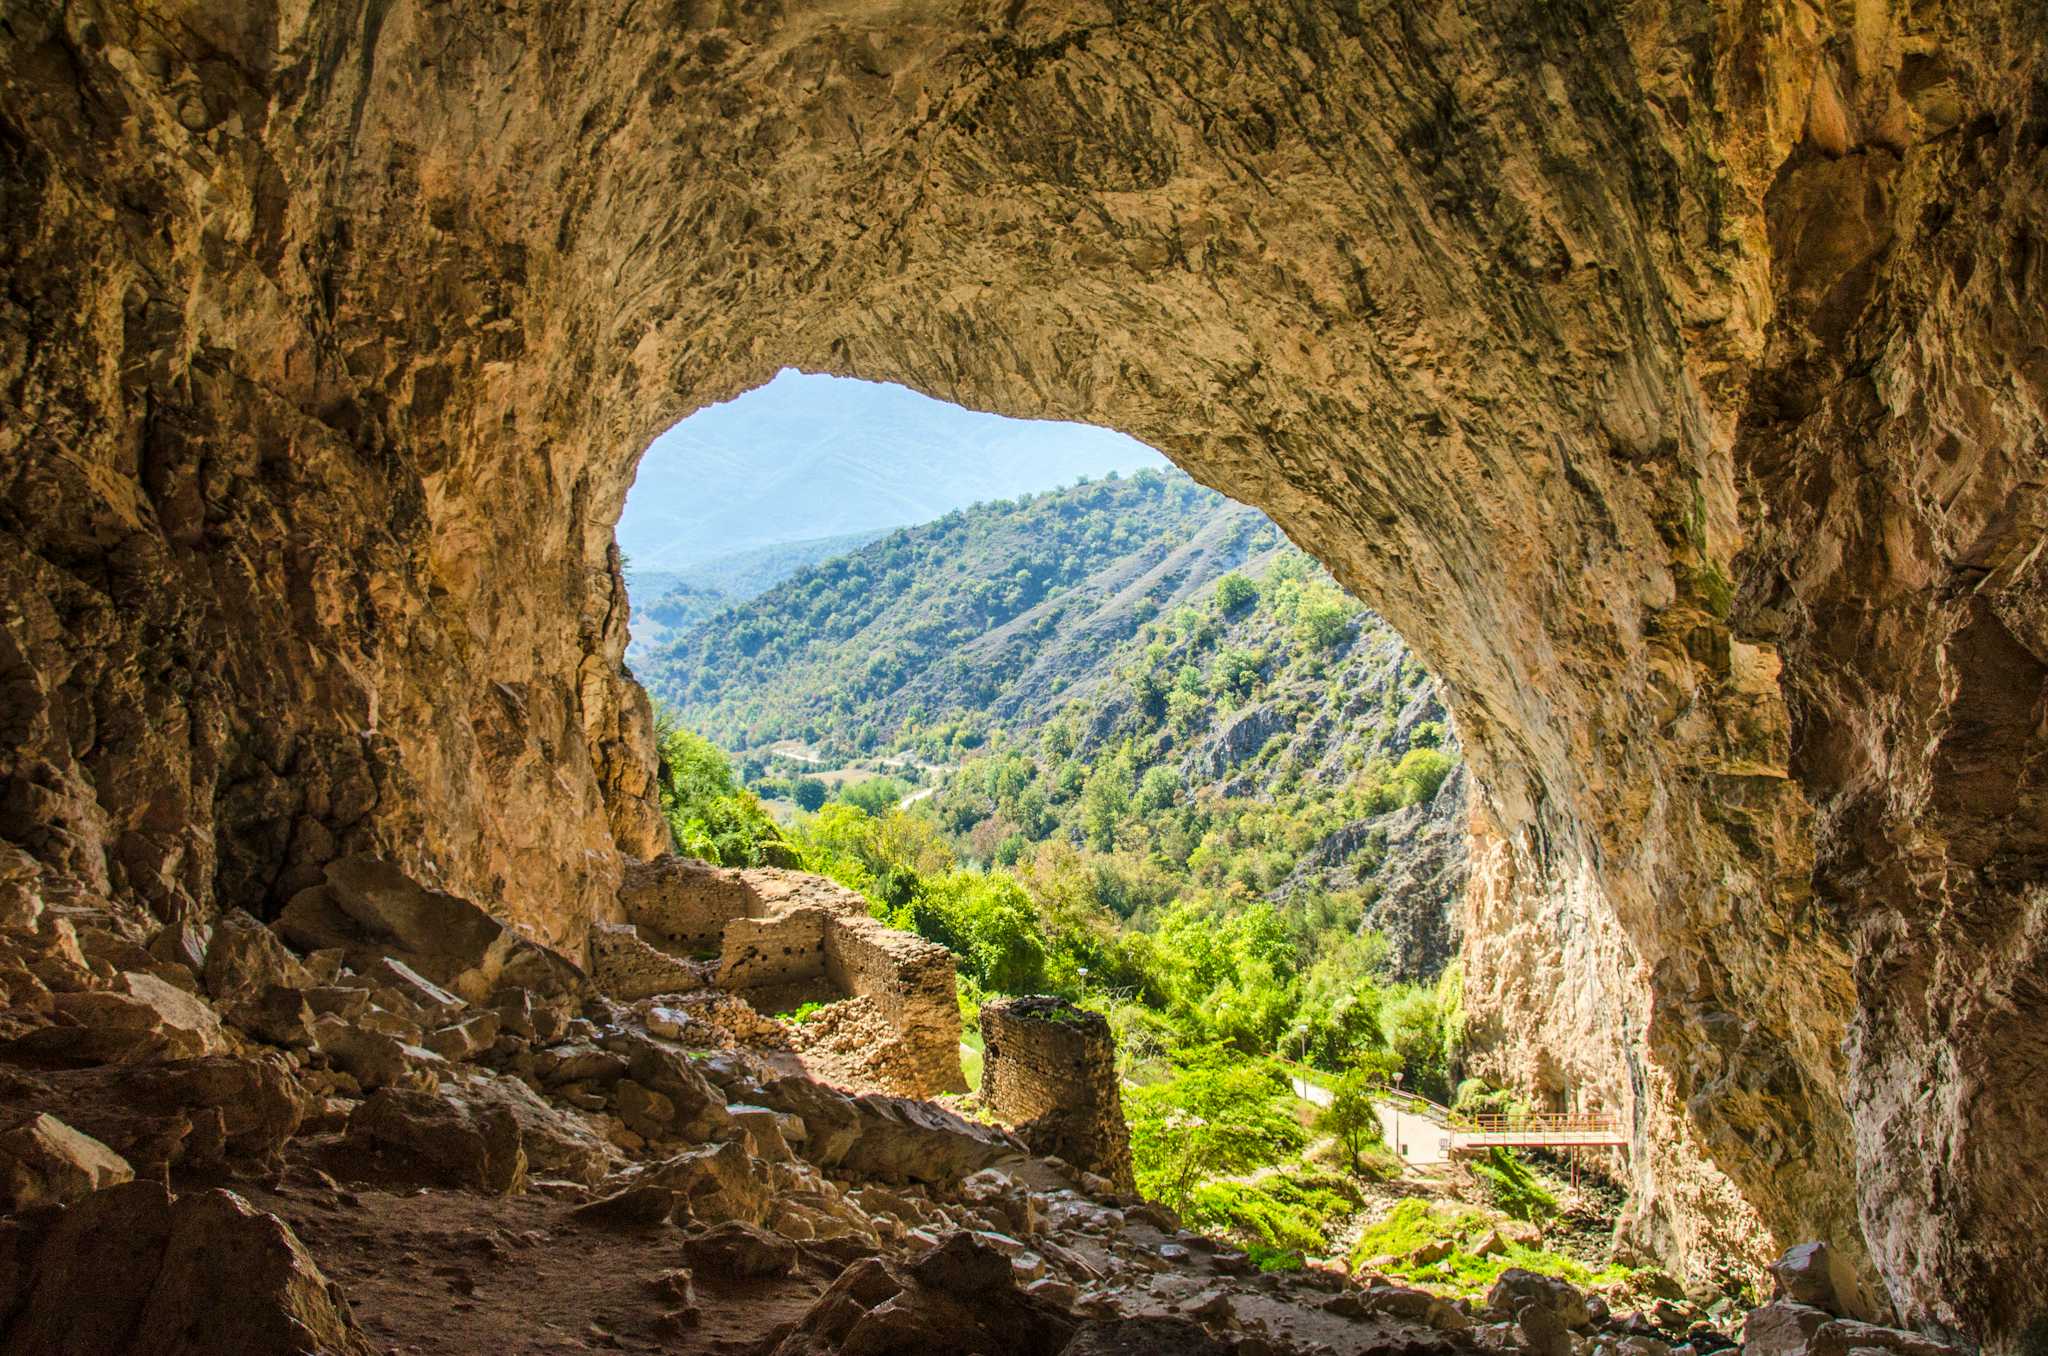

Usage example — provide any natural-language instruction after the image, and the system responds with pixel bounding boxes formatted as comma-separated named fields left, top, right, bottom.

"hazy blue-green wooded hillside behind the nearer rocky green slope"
left=635, top=471, right=1280, bottom=756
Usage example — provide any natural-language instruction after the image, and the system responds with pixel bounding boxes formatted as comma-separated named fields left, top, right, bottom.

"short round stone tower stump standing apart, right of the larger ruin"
left=981, top=995, right=1133, bottom=1192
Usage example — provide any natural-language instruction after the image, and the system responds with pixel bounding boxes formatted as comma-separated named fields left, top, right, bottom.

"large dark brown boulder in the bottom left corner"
left=0, top=1182, right=373, bottom=1356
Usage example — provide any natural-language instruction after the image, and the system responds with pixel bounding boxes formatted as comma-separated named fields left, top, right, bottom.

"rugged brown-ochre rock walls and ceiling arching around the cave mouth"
left=0, top=0, right=2048, bottom=1344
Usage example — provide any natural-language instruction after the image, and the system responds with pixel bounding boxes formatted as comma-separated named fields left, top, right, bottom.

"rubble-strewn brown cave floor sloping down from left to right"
left=0, top=862, right=1944, bottom=1356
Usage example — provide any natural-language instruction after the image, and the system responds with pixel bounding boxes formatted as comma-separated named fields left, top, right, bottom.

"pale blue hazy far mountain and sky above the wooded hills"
left=618, top=371, right=1167, bottom=571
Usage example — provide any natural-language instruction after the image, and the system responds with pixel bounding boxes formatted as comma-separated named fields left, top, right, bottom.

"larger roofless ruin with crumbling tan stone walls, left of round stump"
left=590, top=854, right=967, bottom=1096
